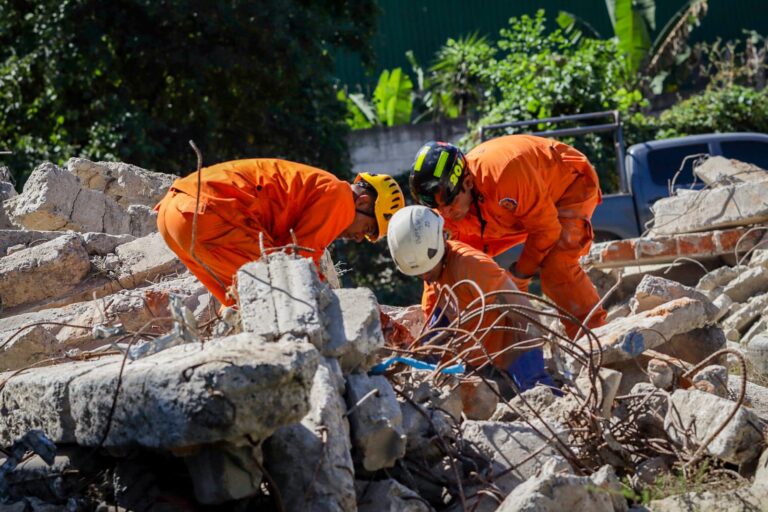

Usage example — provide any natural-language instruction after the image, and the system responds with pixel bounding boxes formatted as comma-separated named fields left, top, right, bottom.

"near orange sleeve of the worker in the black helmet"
left=496, top=161, right=561, bottom=276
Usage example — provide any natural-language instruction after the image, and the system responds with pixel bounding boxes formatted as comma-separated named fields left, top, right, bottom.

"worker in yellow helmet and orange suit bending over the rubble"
left=155, top=159, right=405, bottom=306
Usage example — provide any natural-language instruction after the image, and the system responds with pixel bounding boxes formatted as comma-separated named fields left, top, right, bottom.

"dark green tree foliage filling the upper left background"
left=0, top=0, right=377, bottom=185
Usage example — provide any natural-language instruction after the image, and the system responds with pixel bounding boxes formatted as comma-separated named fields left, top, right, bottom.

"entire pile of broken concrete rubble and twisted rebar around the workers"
left=0, top=159, right=768, bottom=512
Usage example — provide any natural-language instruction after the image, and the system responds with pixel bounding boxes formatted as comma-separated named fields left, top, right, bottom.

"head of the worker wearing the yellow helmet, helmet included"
left=341, top=172, right=405, bottom=242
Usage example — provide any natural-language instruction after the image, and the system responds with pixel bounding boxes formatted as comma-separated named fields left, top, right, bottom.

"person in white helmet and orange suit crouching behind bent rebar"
left=387, top=206, right=554, bottom=391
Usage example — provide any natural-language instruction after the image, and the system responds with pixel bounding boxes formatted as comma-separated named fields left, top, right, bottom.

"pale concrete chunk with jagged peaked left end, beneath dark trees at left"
left=4, top=162, right=157, bottom=236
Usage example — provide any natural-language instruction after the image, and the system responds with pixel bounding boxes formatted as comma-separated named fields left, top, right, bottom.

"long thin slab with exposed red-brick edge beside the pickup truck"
left=581, top=228, right=762, bottom=268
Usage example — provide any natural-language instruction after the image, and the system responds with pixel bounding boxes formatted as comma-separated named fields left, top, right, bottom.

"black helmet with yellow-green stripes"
left=408, top=141, right=467, bottom=208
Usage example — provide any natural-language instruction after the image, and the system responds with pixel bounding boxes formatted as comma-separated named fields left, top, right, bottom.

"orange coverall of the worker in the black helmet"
left=445, top=135, right=606, bottom=337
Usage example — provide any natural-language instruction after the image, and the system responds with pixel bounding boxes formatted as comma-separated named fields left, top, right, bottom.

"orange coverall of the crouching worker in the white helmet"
left=421, top=240, right=527, bottom=368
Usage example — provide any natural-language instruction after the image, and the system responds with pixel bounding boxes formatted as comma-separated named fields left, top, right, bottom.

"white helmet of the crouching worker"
left=387, top=206, right=445, bottom=276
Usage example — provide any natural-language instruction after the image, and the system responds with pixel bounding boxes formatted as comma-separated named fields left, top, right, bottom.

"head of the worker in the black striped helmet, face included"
left=409, top=141, right=474, bottom=220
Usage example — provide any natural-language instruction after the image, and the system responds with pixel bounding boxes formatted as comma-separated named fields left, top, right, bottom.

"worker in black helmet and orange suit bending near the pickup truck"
left=410, top=135, right=606, bottom=338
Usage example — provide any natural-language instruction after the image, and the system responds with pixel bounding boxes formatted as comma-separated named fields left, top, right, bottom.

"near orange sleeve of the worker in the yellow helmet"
left=293, top=179, right=355, bottom=266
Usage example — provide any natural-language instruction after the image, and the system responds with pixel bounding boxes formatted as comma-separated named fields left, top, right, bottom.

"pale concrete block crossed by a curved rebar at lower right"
left=664, top=389, right=763, bottom=464
